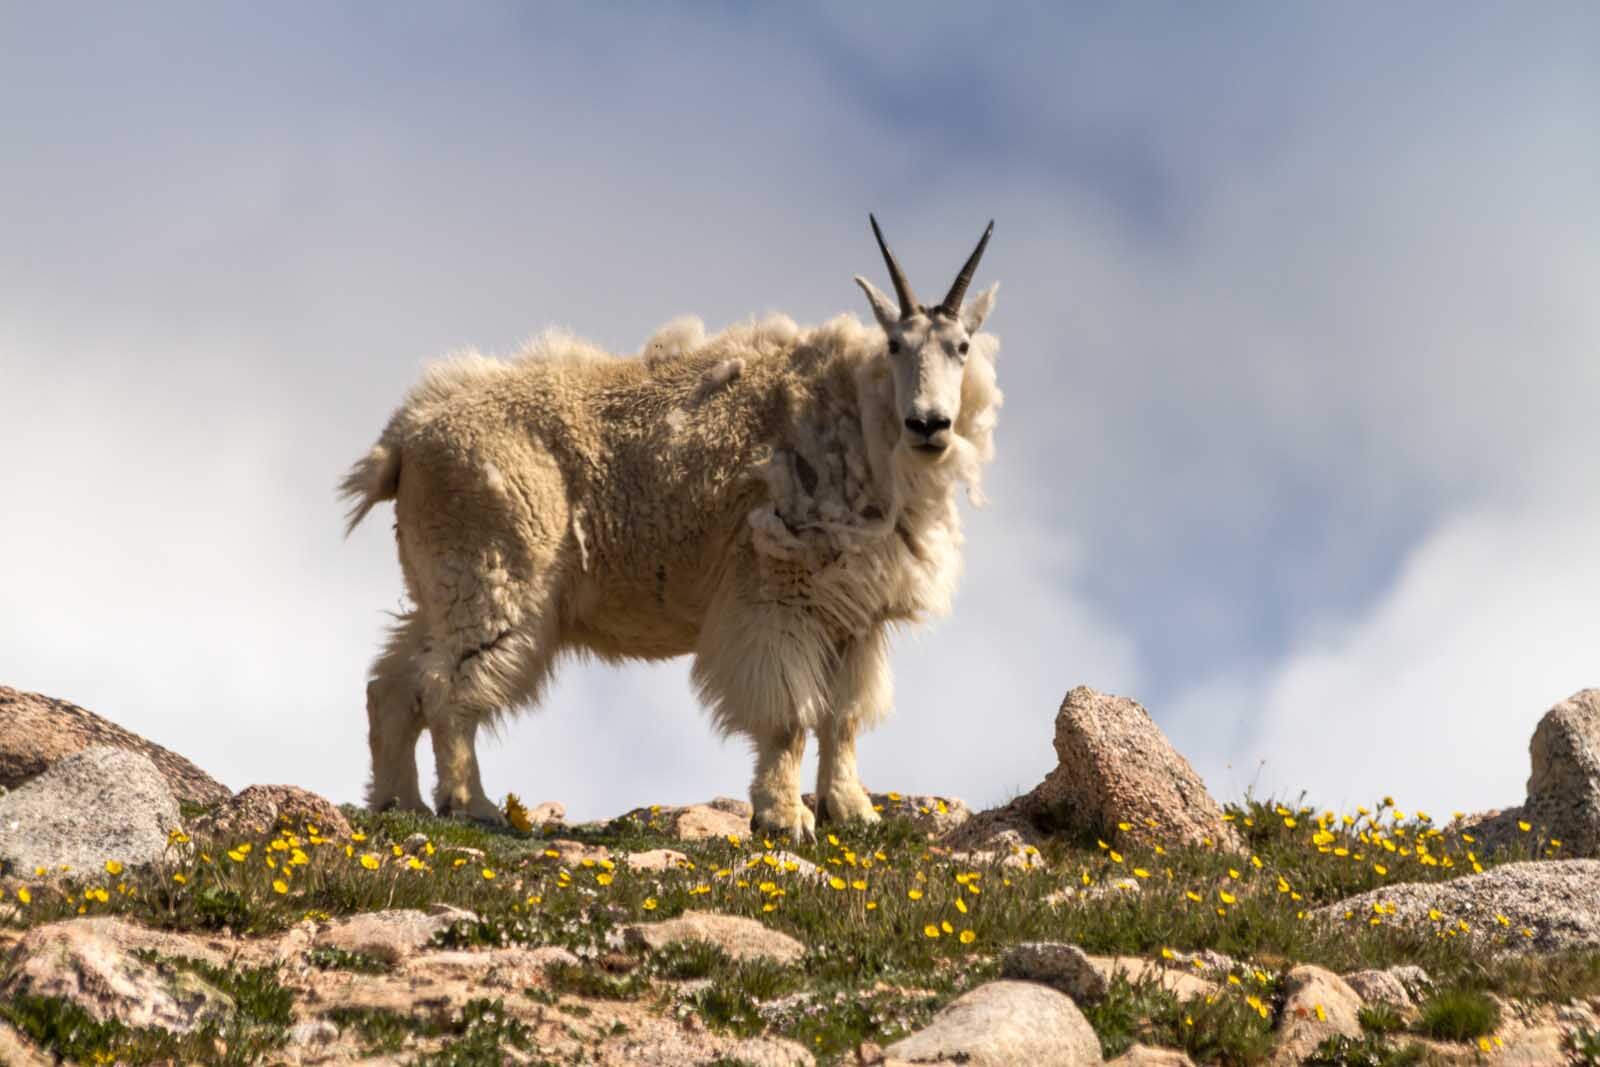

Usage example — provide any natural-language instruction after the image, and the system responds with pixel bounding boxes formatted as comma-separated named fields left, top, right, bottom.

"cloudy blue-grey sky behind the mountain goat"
left=0, top=0, right=1600, bottom=817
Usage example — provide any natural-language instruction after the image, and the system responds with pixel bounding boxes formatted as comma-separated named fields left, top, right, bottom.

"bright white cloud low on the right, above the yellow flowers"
left=1173, top=501, right=1600, bottom=814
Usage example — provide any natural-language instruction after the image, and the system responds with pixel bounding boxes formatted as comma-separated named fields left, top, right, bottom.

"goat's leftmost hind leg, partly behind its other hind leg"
left=366, top=616, right=429, bottom=811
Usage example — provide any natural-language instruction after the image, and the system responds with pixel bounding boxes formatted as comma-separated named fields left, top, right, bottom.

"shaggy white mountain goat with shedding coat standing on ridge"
left=341, top=218, right=1000, bottom=838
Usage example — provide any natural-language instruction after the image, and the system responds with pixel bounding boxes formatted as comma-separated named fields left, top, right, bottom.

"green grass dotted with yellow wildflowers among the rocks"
left=6, top=798, right=1580, bottom=1064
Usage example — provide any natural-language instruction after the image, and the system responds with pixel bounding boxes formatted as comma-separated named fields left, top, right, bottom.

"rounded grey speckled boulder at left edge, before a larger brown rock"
left=0, top=747, right=179, bottom=877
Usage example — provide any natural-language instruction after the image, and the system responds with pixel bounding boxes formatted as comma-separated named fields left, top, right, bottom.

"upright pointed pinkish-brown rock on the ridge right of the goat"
left=1034, top=686, right=1242, bottom=849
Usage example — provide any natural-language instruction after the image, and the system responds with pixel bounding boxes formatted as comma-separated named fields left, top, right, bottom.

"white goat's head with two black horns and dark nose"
left=856, top=214, right=998, bottom=459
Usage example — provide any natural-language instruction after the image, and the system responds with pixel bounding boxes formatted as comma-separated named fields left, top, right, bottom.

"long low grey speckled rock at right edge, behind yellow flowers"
left=1312, top=859, right=1600, bottom=953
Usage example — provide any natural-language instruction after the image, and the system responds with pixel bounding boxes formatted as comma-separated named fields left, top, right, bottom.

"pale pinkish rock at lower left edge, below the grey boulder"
left=0, top=921, right=234, bottom=1032
